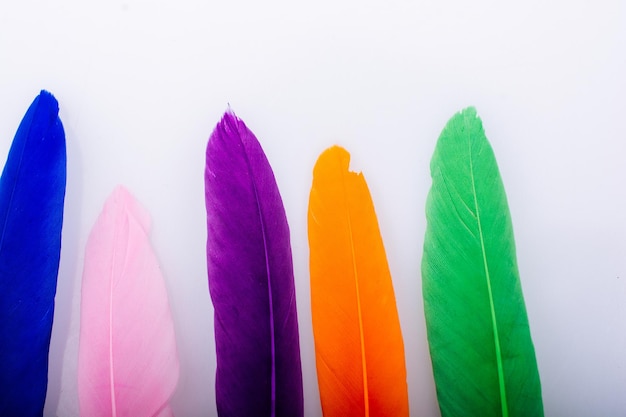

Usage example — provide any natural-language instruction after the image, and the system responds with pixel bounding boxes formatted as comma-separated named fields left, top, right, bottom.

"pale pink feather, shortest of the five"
left=78, top=187, right=179, bottom=417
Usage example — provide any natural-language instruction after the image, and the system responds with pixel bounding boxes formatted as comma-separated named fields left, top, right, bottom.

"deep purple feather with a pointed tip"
left=205, top=112, right=303, bottom=417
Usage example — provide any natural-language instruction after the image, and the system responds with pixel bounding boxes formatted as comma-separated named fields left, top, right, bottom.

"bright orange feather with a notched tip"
left=308, top=146, right=409, bottom=417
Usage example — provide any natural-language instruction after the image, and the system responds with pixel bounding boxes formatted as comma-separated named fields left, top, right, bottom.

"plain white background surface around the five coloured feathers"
left=0, top=0, right=626, bottom=417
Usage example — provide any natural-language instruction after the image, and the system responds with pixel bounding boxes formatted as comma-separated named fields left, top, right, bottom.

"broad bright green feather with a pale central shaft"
left=422, top=108, right=543, bottom=417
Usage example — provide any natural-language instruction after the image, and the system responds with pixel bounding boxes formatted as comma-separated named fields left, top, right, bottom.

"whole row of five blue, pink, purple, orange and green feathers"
left=0, top=91, right=543, bottom=417
